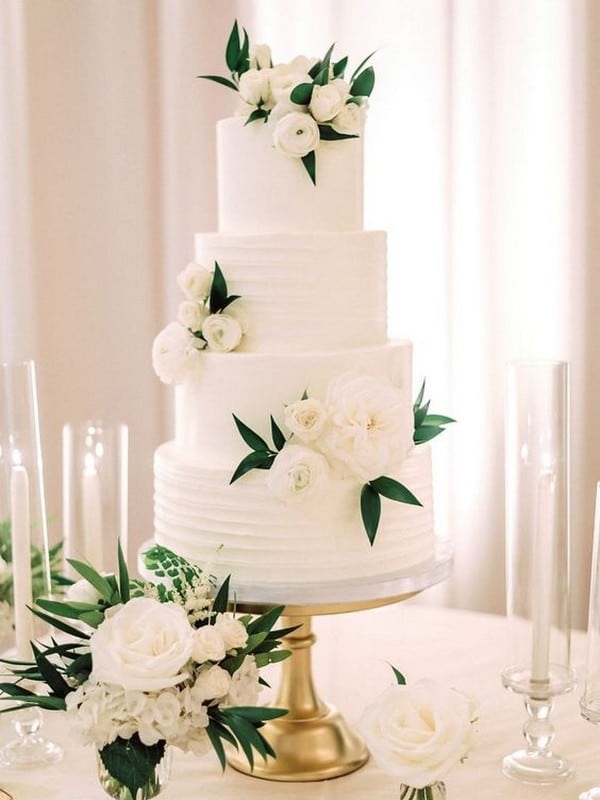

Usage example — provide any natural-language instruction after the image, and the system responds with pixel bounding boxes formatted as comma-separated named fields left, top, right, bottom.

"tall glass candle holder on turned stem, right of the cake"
left=502, top=361, right=575, bottom=784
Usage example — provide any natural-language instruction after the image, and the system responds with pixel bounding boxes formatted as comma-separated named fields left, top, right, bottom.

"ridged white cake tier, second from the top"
left=195, top=231, right=386, bottom=353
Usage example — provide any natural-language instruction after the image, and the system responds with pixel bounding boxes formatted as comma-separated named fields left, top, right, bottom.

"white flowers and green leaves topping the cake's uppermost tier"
left=198, top=21, right=375, bottom=184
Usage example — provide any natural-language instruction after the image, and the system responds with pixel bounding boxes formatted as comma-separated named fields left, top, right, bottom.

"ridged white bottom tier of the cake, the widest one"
left=154, top=442, right=435, bottom=587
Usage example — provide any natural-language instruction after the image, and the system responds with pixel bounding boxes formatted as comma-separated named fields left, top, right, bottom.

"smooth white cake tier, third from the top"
left=175, top=341, right=412, bottom=466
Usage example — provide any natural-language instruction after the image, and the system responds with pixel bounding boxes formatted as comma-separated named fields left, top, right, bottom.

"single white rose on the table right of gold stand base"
left=360, top=681, right=473, bottom=789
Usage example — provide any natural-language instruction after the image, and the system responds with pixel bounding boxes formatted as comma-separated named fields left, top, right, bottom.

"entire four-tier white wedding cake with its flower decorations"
left=153, top=24, right=451, bottom=587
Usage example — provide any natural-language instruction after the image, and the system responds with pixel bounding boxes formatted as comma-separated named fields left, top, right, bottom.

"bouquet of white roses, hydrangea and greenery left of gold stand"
left=0, top=546, right=289, bottom=798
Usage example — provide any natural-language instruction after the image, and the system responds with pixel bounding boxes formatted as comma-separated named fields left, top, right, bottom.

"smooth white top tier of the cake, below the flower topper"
left=217, top=117, right=363, bottom=233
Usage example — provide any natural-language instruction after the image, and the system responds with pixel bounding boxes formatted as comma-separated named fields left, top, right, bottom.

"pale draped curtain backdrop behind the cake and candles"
left=0, top=0, right=600, bottom=624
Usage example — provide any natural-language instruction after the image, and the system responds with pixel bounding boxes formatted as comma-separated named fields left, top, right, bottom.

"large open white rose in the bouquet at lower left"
left=90, top=597, right=194, bottom=691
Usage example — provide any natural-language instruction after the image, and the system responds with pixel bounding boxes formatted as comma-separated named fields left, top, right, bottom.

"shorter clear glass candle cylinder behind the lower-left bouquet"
left=63, top=420, right=128, bottom=578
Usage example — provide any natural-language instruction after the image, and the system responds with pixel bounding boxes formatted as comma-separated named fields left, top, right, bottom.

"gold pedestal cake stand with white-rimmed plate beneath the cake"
left=228, top=543, right=452, bottom=781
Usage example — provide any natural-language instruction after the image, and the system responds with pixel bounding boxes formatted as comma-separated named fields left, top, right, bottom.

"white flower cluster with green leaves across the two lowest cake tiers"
left=230, top=372, right=454, bottom=544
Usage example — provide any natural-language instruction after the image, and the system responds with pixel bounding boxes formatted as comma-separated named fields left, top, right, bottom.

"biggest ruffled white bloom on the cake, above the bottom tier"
left=318, top=371, right=414, bottom=481
